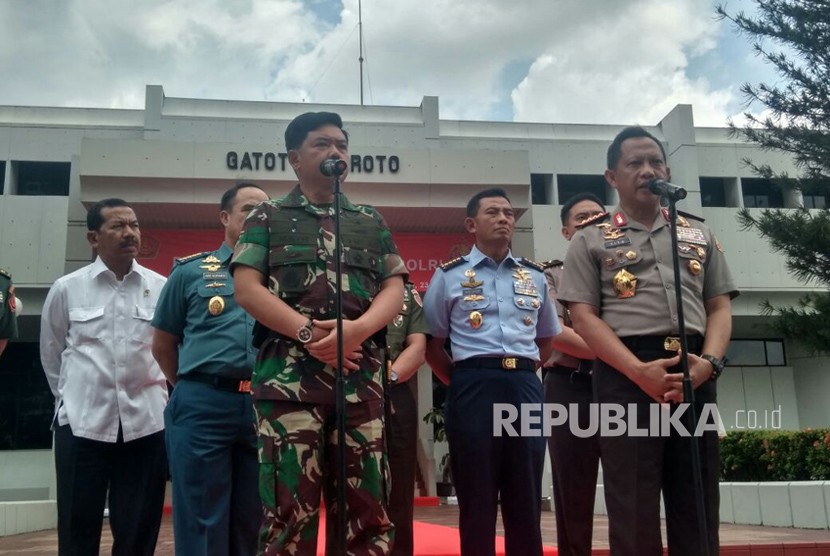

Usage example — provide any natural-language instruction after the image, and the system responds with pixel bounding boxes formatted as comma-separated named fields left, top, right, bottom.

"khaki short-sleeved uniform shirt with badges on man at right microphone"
left=558, top=207, right=738, bottom=337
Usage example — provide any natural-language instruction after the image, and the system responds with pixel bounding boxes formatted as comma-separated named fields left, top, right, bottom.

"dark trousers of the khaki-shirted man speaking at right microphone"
left=594, top=351, right=720, bottom=556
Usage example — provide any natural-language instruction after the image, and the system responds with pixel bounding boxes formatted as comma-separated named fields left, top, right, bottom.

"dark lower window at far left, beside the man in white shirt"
left=0, top=344, right=55, bottom=450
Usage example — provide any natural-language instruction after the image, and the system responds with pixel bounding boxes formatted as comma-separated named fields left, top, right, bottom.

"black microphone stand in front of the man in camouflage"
left=333, top=173, right=346, bottom=554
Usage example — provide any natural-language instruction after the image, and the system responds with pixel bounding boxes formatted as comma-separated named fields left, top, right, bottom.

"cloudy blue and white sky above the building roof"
left=0, top=0, right=776, bottom=127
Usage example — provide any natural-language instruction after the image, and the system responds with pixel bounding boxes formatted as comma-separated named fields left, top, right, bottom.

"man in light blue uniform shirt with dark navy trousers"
left=424, top=189, right=561, bottom=556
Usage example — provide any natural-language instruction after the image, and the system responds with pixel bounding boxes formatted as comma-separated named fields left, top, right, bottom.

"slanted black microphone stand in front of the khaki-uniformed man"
left=663, top=192, right=709, bottom=556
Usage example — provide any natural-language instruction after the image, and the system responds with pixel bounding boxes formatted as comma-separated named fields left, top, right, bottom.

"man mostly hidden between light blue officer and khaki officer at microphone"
left=542, top=193, right=604, bottom=556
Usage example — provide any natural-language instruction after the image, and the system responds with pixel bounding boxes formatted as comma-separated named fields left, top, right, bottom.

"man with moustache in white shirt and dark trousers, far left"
left=40, top=199, right=167, bottom=556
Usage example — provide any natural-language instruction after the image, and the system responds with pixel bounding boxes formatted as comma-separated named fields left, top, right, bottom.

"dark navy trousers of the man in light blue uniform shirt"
left=446, top=368, right=545, bottom=556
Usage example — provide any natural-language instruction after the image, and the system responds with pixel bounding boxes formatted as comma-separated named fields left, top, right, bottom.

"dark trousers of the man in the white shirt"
left=55, top=425, right=167, bottom=556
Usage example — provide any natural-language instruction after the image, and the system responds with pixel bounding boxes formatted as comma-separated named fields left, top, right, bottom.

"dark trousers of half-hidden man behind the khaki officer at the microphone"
left=544, top=367, right=599, bottom=556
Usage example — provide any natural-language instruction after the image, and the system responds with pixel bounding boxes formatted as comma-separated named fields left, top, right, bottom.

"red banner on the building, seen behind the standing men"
left=138, top=228, right=473, bottom=292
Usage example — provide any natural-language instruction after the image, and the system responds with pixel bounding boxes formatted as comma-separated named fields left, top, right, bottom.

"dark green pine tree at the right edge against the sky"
left=716, top=0, right=830, bottom=351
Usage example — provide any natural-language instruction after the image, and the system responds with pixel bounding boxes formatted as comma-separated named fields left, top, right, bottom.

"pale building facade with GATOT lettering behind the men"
left=0, top=85, right=830, bottom=508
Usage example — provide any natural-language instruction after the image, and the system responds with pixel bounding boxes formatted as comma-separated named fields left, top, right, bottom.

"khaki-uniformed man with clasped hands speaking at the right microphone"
left=559, top=127, right=737, bottom=556
